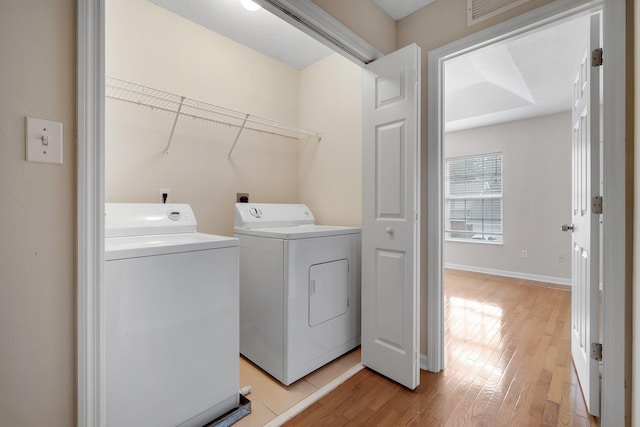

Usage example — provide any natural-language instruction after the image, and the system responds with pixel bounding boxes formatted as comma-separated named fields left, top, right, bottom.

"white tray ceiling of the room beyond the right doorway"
left=444, top=17, right=589, bottom=131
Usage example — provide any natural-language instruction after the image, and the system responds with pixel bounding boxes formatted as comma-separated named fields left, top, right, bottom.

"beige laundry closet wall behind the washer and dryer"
left=105, top=0, right=361, bottom=235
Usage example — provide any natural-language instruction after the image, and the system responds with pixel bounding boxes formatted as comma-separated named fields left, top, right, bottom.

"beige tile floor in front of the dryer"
left=234, top=347, right=360, bottom=427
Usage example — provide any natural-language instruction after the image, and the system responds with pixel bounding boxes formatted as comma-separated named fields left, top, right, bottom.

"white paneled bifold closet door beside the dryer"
left=362, top=44, right=420, bottom=389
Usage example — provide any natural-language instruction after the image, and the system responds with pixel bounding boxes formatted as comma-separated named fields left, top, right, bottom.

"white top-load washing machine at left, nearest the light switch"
left=103, top=203, right=240, bottom=427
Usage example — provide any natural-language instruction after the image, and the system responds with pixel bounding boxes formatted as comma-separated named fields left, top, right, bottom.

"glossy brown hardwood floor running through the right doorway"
left=285, top=270, right=598, bottom=426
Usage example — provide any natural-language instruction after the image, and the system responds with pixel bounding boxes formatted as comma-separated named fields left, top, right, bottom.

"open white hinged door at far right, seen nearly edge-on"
left=569, top=14, right=600, bottom=416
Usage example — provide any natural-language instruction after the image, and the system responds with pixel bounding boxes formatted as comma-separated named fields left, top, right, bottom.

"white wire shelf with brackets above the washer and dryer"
left=105, top=77, right=322, bottom=158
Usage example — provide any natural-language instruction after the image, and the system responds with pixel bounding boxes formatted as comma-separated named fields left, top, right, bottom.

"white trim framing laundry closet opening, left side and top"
left=76, top=0, right=384, bottom=427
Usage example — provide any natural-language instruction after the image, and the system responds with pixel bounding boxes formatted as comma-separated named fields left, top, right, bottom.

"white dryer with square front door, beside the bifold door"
left=234, top=203, right=361, bottom=385
